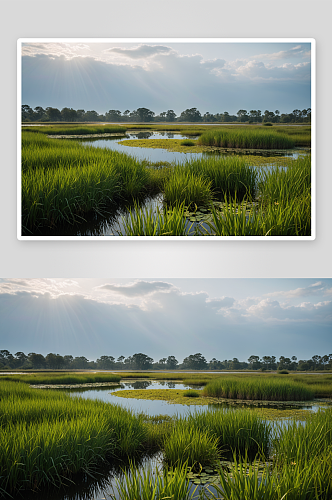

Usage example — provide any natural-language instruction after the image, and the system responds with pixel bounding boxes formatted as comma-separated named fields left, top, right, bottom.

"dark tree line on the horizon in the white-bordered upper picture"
left=22, top=104, right=311, bottom=123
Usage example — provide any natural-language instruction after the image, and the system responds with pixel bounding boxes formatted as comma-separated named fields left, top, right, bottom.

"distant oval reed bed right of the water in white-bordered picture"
left=198, top=128, right=295, bottom=149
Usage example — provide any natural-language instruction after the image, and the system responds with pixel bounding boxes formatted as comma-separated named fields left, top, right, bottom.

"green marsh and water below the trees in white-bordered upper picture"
left=21, top=125, right=311, bottom=237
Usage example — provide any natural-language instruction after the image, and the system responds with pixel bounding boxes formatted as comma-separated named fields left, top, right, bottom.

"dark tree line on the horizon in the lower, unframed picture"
left=0, top=349, right=332, bottom=371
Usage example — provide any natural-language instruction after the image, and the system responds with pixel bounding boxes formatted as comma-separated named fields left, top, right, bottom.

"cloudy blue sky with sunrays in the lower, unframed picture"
left=0, top=278, right=332, bottom=362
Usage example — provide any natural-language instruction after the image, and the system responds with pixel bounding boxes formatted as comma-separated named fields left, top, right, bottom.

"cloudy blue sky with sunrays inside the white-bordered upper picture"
left=22, top=39, right=311, bottom=116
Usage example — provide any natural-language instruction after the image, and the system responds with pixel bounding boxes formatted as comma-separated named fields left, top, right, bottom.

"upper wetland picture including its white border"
left=17, top=38, right=316, bottom=241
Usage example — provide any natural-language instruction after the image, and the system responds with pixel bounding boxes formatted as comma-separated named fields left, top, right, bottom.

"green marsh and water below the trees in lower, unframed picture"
left=0, top=372, right=332, bottom=500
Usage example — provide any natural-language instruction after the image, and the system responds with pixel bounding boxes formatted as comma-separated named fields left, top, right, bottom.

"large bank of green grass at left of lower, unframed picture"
left=0, top=381, right=146, bottom=494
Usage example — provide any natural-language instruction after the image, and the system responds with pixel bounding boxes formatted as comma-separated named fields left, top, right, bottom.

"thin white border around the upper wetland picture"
left=17, top=38, right=316, bottom=241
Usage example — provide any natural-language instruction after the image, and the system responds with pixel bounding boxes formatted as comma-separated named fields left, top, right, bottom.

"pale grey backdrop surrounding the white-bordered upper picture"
left=0, top=0, right=332, bottom=278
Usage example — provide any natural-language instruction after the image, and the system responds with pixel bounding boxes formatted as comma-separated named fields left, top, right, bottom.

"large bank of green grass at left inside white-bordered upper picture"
left=22, top=132, right=150, bottom=232
